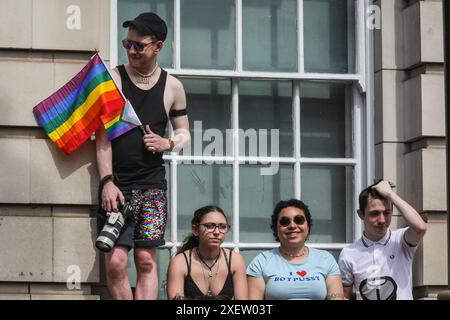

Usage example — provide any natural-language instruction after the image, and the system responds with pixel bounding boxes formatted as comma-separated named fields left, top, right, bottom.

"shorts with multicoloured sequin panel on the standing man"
left=97, top=189, right=167, bottom=249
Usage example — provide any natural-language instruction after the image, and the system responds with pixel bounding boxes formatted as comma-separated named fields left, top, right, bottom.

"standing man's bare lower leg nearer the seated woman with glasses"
left=134, top=247, right=158, bottom=300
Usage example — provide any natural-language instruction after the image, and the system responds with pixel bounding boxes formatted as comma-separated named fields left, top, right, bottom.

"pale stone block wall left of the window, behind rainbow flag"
left=0, top=0, right=110, bottom=299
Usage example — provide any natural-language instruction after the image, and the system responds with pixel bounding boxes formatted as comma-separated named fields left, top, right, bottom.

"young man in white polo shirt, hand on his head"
left=339, top=180, right=427, bottom=300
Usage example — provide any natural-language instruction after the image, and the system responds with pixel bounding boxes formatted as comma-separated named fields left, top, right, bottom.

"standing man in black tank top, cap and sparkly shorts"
left=96, top=12, right=190, bottom=300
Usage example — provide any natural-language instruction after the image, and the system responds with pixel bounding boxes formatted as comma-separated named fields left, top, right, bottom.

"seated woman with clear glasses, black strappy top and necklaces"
left=167, top=206, right=247, bottom=300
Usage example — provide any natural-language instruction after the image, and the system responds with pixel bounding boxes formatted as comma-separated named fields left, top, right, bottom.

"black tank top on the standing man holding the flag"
left=111, top=65, right=168, bottom=190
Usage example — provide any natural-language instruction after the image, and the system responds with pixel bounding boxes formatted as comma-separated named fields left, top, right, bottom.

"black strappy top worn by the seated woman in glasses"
left=183, top=248, right=234, bottom=300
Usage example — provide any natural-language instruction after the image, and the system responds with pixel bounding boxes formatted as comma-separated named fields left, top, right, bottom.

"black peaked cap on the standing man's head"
left=122, top=12, right=167, bottom=41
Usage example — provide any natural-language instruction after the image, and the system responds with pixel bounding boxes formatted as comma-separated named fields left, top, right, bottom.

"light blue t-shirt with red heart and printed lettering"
left=247, top=247, right=340, bottom=300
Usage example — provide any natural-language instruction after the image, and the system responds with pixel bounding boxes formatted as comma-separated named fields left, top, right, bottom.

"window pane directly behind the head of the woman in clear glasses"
left=178, top=164, right=233, bottom=241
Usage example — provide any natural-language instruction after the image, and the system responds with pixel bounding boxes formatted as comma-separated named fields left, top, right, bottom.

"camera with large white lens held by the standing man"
left=95, top=203, right=131, bottom=252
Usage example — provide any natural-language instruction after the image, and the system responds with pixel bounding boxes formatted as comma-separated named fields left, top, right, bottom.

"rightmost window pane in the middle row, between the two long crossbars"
left=300, top=82, right=353, bottom=158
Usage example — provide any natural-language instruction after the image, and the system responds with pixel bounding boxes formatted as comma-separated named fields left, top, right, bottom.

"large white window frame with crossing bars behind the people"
left=110, top=0, right=374, bottom=254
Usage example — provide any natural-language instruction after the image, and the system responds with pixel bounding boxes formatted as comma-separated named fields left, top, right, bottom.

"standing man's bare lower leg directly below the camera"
left=105, top=246, right=133, bottom=300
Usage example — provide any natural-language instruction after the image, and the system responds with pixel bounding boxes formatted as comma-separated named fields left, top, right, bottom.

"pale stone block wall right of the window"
left=374, top=0, right=447, bottom=298
